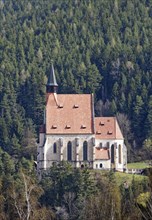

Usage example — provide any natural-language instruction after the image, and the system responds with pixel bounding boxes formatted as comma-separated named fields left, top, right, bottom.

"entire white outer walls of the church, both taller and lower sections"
left=37, top=133, right=127, bottom=171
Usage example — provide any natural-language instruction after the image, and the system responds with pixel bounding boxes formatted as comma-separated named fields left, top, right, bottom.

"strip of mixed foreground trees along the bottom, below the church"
left=0, top=153, right=152, bottom=220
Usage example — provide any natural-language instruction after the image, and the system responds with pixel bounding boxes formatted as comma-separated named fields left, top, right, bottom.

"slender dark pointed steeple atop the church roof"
left=46, top=64, right=58, bottom=93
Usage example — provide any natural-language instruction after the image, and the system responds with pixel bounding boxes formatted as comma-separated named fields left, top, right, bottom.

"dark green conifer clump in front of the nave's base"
left=41, top=162, right=95, bottom=206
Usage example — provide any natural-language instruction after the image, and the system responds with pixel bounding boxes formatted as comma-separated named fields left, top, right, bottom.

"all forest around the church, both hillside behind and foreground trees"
left=0, top=0, right=152, bottom=220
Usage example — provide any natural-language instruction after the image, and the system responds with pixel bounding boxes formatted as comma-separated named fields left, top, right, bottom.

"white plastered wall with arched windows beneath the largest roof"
left=41, top=135, right=94, bottom=169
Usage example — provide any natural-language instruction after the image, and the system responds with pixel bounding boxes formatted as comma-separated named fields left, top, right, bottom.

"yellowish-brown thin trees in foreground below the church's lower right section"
left=80, top=172, right=121, bottom=220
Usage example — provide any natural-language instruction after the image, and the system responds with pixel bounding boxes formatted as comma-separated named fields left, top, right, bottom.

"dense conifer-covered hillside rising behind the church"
left=0, top=0, right=152, bottom=158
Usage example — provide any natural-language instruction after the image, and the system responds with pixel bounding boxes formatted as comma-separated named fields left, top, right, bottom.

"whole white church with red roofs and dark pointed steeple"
left=37, top=66, right=127, bottom=173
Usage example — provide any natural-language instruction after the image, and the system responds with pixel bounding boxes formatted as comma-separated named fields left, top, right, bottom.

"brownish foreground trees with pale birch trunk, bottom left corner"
left=0, top=149, right=55, bottom=220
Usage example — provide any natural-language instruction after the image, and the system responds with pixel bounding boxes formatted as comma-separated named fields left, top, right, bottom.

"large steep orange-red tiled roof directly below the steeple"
left=46, top=93, right=94, bottom=134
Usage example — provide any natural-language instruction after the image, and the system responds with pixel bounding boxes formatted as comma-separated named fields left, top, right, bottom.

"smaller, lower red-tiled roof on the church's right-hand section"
left=95, top=117, right=124, bottom=140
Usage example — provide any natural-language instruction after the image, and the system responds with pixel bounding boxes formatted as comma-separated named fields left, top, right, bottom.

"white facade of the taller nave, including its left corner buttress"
left=37, top=133, right=94, bottom=170
